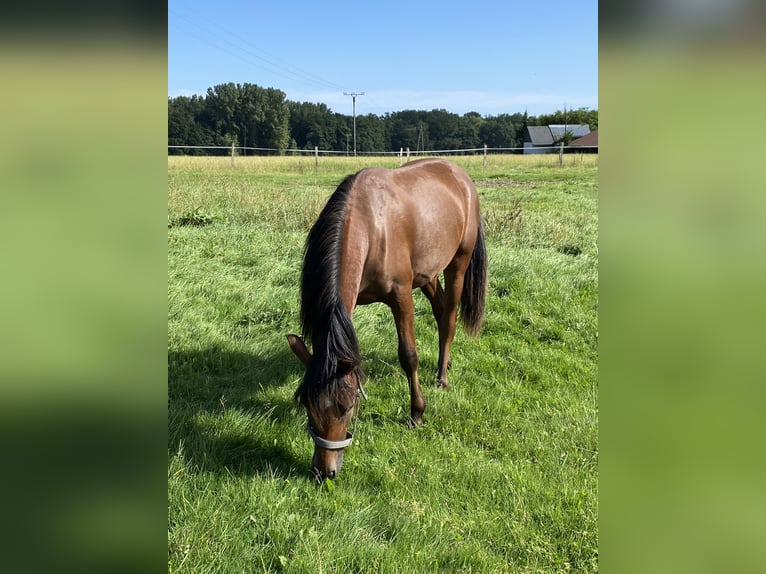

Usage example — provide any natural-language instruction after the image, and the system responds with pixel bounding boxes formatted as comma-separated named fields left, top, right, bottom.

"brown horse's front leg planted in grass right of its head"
left=389, top=289, right=426, bottom=426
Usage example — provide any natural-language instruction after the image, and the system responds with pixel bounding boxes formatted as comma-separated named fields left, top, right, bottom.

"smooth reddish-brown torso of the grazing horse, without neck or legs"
left=348, top=159, right=478, bottom=300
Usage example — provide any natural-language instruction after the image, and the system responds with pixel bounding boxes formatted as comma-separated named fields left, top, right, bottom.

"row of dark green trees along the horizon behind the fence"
left=168, top=83, right=598, bottom=155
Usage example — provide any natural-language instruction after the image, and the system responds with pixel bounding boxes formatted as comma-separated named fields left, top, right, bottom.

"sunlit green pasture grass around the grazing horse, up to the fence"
left=168, top=156, right=598, bottom=573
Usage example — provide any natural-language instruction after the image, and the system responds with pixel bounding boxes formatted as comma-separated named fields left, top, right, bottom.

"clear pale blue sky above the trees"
left=168, top=0, right=598, bottom=116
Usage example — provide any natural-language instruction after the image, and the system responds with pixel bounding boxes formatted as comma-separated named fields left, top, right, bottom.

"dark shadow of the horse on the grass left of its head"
left=168, top=344, right=310, bottom=478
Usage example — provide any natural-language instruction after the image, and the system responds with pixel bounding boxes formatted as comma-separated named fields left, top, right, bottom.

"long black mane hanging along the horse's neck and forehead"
left=295, top=175, right=364, bottom=405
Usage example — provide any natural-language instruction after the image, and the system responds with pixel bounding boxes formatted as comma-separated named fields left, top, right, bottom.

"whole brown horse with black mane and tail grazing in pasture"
left=287, top=159, right=487, bottom=480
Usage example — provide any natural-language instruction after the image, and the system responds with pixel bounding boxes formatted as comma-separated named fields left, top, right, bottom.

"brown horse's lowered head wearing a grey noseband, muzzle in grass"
left=287, top=335, right=364, bottom=481
